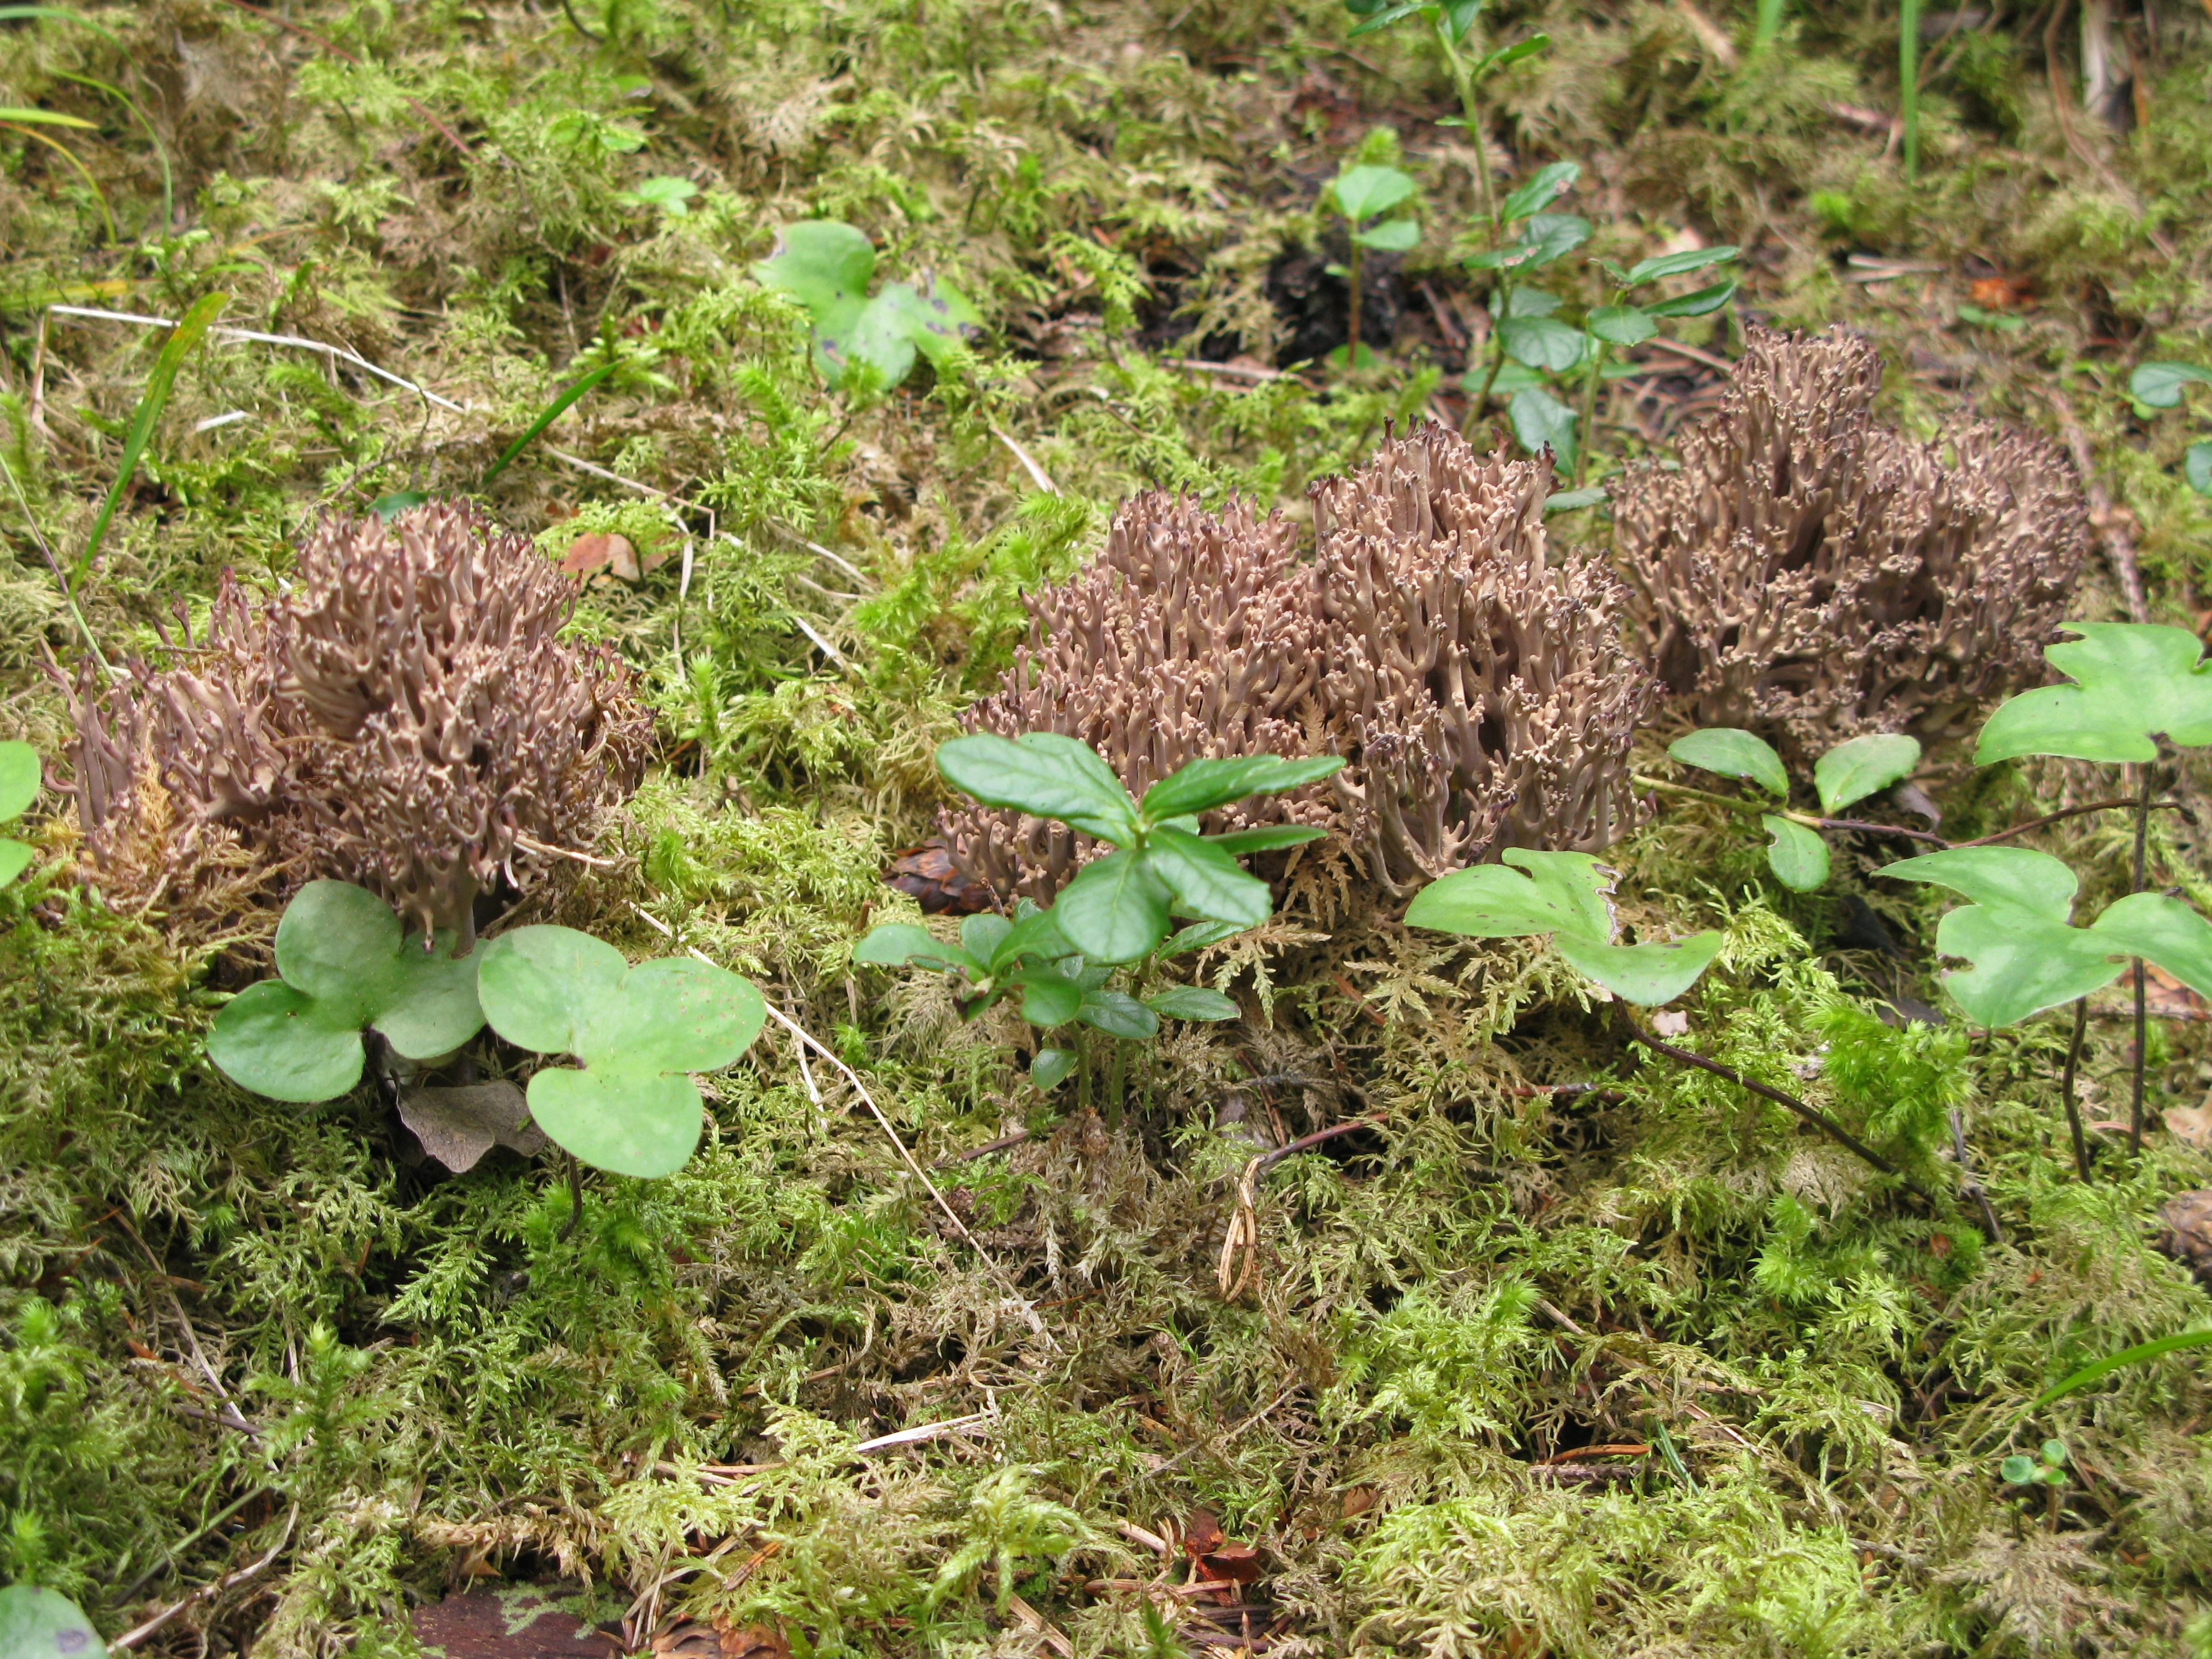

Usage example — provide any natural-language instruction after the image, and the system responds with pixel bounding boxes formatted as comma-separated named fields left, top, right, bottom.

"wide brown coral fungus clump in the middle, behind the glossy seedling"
left=945, top=425, right=1652, bottom=900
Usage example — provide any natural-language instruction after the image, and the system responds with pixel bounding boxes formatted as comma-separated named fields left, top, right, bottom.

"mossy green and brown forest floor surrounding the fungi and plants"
left=0, top=0, right=2212, bottom=1659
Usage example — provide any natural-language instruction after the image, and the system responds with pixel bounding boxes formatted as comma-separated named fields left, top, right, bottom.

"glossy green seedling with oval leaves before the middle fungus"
left=854, top=732, right=1343, bottom=1088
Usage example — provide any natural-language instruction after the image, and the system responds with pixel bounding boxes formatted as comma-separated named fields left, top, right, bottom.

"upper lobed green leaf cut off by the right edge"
left=1973, top=622, right=2212, bottom=765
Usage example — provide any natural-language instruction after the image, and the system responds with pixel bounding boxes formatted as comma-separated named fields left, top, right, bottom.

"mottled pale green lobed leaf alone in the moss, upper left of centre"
left=752, top=219, right=982, bottom=389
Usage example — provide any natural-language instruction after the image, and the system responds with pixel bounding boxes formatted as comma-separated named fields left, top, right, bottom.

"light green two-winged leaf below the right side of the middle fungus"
left=1405, top=847, right=1721, bottom=1006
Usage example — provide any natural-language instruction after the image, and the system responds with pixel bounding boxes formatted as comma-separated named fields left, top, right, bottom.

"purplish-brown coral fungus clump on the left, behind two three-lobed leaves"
left=60, top=502, right=653, bottom=940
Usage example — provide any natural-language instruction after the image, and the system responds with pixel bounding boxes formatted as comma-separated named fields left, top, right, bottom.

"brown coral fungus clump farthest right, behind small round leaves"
left=1613, top=330, right=2088, bottom=750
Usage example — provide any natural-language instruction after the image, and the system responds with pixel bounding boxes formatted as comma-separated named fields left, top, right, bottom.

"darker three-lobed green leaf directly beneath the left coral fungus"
left=208, top=880, right=484, bottom=1102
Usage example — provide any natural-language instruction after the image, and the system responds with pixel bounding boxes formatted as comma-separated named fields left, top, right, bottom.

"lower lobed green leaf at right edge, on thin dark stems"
left=1882, top=847, right=2212, bottom=1026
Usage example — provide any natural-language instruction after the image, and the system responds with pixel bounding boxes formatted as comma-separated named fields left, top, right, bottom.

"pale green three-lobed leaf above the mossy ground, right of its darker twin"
left=478, top=927, right=768, bottom=1177
